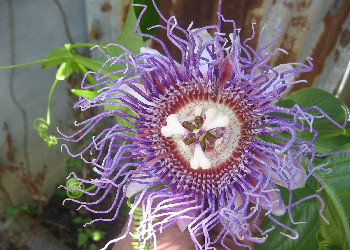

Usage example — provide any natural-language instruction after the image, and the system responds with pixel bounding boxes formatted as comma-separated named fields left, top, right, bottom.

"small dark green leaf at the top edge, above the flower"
left=133, top=0, right=160, bottom=41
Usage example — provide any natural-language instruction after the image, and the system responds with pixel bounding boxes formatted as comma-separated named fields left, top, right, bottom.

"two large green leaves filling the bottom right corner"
left=256, top=144, right=350, bottom=250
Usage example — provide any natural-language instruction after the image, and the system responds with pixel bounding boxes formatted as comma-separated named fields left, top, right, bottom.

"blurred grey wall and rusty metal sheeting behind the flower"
left=0, top=0, right=350, bottom=249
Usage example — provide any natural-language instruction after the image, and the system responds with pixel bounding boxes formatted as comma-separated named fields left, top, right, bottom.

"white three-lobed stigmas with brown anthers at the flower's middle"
left=161, top=105, right=235, bottom=169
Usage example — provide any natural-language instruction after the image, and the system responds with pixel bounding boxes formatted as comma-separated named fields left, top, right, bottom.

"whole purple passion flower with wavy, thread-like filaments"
left=59, top=0, right=344, bottom=249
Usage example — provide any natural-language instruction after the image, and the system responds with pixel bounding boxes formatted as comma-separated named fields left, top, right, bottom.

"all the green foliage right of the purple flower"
left=256, top=88, right=350, bottom=250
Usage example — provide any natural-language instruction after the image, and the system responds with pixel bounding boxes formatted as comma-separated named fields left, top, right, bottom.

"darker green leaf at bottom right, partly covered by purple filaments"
left=255, top=179, right=319, bottom=250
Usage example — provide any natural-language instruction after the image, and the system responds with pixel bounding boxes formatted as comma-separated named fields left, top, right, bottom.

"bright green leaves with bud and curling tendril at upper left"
left=35, top=1, right=146, bottom=146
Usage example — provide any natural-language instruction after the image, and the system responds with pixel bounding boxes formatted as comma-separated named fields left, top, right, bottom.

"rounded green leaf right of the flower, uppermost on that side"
left=284, top=88, right=345, bottom=138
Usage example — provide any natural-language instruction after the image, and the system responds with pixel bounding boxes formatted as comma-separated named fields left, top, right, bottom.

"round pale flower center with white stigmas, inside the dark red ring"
left=161, top=101, right=240, bottom=169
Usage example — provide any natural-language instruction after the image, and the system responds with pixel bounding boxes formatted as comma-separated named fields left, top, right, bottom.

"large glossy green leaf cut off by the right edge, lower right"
left=317, top=143, right=350, bottom=249
